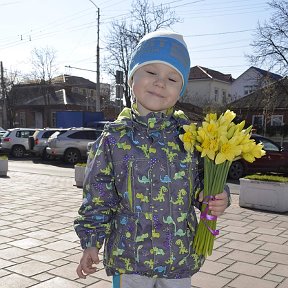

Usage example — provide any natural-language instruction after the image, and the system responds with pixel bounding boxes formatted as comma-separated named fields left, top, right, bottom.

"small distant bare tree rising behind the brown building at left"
left=31, top=47, right=57, bottom=84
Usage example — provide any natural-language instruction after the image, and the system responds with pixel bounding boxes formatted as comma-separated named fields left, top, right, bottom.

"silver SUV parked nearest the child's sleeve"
left=46, top=128, right=102, bottom=164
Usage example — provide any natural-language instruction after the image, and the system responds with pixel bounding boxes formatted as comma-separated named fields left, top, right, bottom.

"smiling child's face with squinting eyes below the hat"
left=132, top=63, right=182, bottom=116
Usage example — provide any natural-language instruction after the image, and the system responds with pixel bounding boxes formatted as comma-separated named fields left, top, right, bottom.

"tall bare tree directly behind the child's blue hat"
left=105, top=0, right=180, bottom=107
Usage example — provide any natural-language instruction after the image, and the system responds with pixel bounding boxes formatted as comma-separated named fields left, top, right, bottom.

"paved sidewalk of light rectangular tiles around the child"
left=0, top=171, right=288, bottom=288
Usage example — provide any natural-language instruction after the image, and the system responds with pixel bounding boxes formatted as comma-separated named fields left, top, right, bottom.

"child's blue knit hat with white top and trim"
left=128, top=30, right=190, bottom=96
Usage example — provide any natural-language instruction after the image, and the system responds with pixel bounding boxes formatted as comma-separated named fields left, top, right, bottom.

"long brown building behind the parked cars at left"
left=8, top=75, right=113, bottom=128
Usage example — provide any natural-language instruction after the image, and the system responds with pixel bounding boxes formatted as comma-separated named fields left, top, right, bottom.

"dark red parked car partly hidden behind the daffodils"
left=228, top=134, right=288, bottom=180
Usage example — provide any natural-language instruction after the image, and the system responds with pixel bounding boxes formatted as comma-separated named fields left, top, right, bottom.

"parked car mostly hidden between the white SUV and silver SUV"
left=29, top=128, right=67, bottom=159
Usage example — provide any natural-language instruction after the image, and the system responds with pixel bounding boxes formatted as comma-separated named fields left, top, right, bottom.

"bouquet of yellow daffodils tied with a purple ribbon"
left=179, top=110, right=265, bottom=257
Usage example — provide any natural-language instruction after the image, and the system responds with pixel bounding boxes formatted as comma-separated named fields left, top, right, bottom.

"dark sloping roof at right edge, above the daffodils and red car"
left=228, top=77, right=288, bottom=109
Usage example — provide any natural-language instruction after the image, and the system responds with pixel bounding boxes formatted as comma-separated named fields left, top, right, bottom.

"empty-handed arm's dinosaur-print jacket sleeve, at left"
left=74, top=133, right=119, bottom=249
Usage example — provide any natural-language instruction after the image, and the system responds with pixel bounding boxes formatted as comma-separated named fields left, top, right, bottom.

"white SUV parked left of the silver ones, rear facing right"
left=0, top=128, right=36, bottom=158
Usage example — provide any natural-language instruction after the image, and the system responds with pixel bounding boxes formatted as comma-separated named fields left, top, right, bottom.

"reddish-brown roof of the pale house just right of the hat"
left=189, top=66, right=233, bottom=82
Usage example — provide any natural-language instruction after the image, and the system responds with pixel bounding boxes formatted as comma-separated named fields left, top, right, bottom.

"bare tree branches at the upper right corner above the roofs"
left=248, top=0, right=288, bottom=75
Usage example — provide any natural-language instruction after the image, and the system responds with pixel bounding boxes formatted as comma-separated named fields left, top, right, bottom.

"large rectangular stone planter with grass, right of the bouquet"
left=239, top=178, right=288, bottom=212
